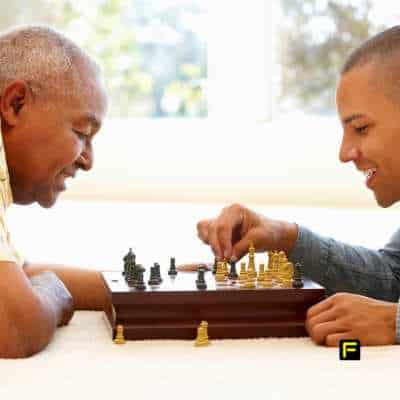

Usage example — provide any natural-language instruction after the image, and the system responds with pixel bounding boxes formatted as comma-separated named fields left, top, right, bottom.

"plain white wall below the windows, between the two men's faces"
left=63, top=115, right=382, bottom=207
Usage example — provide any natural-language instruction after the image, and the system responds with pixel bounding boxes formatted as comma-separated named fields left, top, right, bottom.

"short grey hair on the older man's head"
left=0, top=26, right=99, bottom=96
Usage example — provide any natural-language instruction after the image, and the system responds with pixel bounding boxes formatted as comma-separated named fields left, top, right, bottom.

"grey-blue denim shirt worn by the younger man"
left=288, top=226, right=400, bottom=343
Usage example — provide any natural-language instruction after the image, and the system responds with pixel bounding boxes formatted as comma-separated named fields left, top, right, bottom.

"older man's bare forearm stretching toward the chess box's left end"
left=24, top=263, right=110, bottom=310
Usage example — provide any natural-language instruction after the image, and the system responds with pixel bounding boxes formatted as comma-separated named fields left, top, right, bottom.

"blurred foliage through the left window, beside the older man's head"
left=0, top=0, right=207, bottom=117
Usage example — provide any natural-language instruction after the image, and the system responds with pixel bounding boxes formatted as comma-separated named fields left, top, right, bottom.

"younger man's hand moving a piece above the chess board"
left=197, top=204, right=298, bottom=261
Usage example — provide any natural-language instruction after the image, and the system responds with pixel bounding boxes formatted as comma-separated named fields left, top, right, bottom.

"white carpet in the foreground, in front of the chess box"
left=0, top=311, right=400, bottom=400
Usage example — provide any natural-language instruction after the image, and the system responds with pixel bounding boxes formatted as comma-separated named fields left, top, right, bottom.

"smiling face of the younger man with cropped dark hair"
left=336, top=64, right=400, bottom=207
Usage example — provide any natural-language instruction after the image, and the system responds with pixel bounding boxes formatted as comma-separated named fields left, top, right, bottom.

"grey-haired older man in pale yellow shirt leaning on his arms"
left=0, top=27, right=108, bottom=357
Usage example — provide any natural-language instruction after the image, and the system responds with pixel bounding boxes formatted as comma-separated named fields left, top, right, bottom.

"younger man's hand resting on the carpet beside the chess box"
left=306, top=293, right=397, bottom=346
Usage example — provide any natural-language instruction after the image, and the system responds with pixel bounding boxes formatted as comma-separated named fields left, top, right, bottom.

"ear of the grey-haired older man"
left=0, top=81, right=33, bottom=126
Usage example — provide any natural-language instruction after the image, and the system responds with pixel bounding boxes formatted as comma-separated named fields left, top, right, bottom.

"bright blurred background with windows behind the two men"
left=0, top=0, right=400, bottom=264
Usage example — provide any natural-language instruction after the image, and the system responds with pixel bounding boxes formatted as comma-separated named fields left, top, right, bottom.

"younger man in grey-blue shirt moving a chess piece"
left=198, top=26, right=400, bottom=346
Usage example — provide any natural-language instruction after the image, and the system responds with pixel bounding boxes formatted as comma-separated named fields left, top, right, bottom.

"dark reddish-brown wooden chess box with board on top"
left=102, top=271, right=325, bottom=340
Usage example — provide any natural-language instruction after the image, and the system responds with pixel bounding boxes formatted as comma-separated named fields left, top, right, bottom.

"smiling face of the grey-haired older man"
left=5, top=67, right=106, bottom=207
